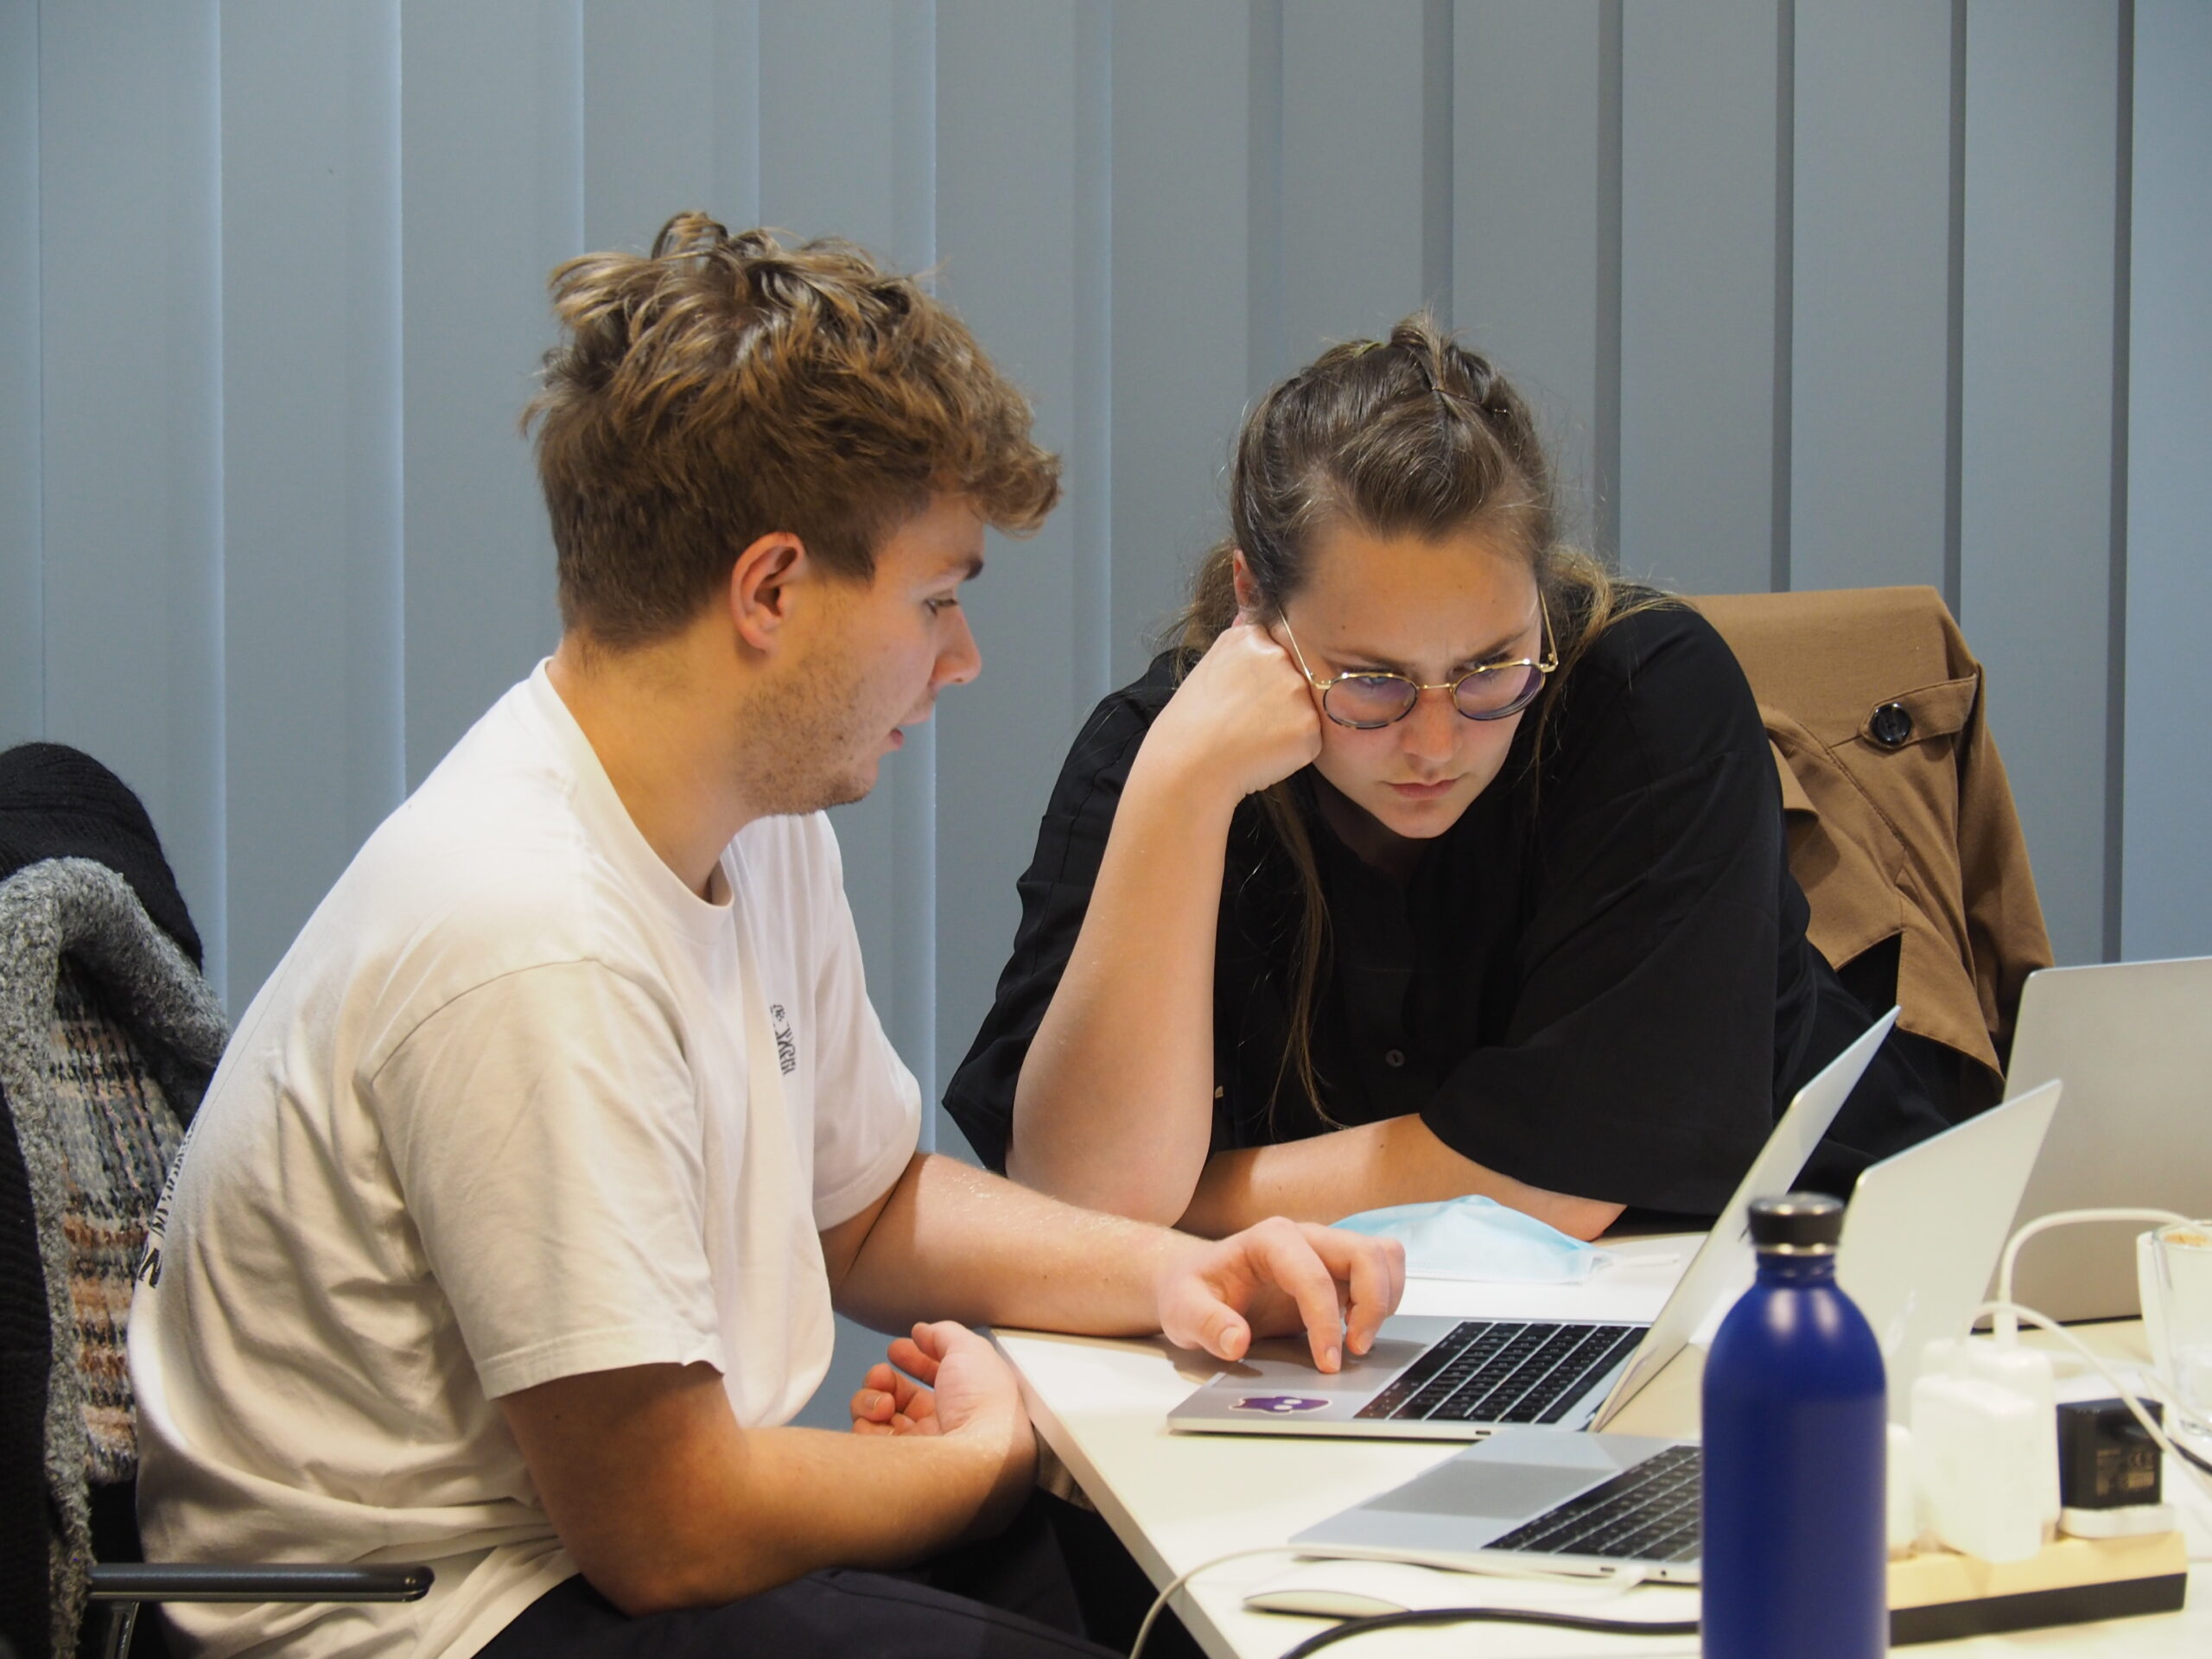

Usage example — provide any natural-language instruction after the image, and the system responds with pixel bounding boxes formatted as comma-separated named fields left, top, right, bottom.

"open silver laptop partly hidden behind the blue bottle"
left=1289, top=1084, right=2059, bottom=1581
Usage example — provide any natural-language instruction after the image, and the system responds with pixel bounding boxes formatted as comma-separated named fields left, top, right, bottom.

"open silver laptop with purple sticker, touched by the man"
left=1168, top=1008, right=1902, bottom=1440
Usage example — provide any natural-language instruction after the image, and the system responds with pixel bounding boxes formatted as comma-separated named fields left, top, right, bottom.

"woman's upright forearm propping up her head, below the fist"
left=1007, top=747, right=1239, bottom=1221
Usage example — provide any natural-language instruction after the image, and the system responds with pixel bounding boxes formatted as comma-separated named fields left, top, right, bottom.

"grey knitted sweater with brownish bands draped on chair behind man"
left=0, top=746, right=228, bottom=1655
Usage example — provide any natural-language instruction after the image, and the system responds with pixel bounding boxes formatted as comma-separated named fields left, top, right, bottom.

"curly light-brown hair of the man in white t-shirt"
left=522, top=213, right=1059, bottom=648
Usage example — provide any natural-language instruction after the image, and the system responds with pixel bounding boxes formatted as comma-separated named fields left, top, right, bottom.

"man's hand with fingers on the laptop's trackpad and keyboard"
left=1157, top=1217, right=1405, bottom=1371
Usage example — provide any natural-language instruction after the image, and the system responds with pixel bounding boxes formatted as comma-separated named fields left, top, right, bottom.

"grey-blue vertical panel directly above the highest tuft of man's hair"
left=584, top=0, right=761, bottom=252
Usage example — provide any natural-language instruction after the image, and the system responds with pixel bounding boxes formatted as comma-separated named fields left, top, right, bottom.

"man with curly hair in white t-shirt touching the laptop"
left=130, top=214, right=1402, bottom=1659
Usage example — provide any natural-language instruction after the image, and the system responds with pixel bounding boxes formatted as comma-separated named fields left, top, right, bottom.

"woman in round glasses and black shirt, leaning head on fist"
left=947, top=316, right=1947, bottom=1236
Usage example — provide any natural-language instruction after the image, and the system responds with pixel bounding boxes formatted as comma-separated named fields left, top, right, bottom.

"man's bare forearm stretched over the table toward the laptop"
left=836, top=1154, right=1194, bottom=1336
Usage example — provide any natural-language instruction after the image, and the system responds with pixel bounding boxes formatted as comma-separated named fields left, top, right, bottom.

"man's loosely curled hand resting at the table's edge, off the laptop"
left=852, top=1320, right=1038, bottom=1537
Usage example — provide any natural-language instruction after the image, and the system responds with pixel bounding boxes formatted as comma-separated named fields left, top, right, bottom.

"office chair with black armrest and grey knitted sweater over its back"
left=0, top=787, right=431, bottom=1659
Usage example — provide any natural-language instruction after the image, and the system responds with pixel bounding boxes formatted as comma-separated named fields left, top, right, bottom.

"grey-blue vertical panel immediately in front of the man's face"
left=936, top=0, right=1109, bottom=1159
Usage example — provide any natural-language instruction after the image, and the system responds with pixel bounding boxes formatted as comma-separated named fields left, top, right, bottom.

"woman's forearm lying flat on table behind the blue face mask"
left=1177, top=1117, right=1621, bottom=1239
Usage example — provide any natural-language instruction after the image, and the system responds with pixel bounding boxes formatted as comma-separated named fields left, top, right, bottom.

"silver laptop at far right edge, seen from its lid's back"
left=2006, top=956, right=2212, bottom=1319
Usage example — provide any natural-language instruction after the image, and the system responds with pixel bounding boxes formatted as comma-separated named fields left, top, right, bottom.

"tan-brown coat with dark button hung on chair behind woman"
left=1690, top=588, right=2050, bottom=1110
